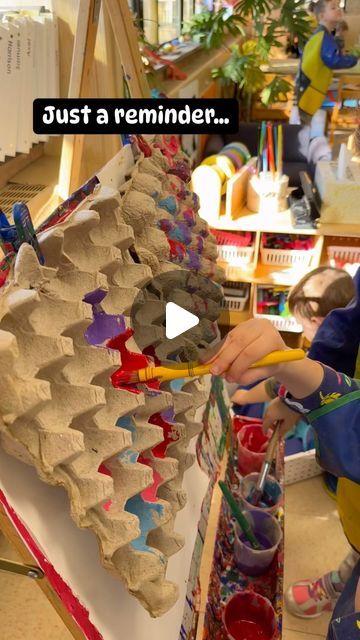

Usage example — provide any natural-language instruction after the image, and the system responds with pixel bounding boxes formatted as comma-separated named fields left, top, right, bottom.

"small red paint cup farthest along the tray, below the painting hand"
left=237, top=424, right=269, bottom=476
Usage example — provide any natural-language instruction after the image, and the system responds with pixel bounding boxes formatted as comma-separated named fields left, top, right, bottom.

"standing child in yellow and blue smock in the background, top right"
left=296, top=0, right=357, bottom=125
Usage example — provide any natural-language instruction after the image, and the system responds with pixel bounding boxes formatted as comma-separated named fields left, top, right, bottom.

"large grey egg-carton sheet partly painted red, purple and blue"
left=0, top=136, right=223, bottom=617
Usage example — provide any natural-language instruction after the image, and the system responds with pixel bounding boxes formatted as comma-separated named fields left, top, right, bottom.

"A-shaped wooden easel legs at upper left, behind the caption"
left=59, top=0, right=150, bottom=200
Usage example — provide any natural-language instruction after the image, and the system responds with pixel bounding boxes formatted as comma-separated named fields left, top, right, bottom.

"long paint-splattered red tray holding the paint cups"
left=202, top=422, right=284, bottom=640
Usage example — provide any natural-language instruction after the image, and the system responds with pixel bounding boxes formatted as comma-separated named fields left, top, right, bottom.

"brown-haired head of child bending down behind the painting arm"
left=288, top=267, right=355, bottom=341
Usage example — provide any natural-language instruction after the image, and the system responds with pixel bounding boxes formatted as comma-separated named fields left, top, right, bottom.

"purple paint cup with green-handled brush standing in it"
left=234, top=509, right=282, bottom=576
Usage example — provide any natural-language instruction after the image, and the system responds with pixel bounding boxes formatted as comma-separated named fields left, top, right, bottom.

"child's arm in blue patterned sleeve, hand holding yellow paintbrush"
left=211, top=320, right=360, bottom=483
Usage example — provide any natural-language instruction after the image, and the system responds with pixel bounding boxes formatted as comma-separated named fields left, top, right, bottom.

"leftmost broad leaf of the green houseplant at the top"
left=182, top=9, right=245, bottom=49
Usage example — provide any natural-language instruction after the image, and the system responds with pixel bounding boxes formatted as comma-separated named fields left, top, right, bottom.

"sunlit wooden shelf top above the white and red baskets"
left=208, top=208, right=360, bottom=237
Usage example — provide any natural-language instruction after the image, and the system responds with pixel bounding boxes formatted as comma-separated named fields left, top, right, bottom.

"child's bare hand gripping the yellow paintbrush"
left=211, top=320, right=286, bottom=384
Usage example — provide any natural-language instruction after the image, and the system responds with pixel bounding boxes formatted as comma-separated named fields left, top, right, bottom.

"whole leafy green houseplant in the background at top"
left=187, top=0, right=311, bottom=119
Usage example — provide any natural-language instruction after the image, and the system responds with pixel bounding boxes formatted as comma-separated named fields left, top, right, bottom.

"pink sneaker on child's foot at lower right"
left=285, top=571, right=344, bottom=618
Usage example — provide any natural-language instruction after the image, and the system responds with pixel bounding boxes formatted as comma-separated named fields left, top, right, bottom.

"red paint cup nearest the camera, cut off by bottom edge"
left=223, top=591, right=279, bottom=640
